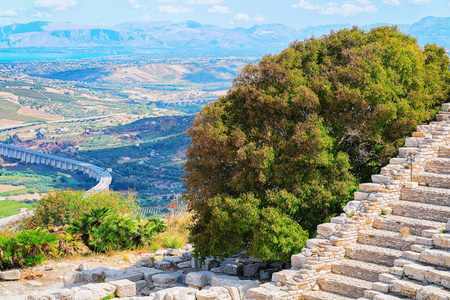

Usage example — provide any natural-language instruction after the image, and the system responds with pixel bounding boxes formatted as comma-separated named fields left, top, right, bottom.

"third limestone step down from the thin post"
left=373, top=215, right=445, bottom=235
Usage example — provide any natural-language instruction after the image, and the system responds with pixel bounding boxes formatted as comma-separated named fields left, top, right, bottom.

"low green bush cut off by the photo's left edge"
left=0, top=228, right=77, bottom=270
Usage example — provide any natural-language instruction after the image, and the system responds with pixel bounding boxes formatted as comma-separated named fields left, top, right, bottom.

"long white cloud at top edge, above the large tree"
left=292, top=0, right=376, bottom=17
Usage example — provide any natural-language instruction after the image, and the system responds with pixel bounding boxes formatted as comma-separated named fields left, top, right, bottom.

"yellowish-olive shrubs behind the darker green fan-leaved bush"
left=27, top=190, right=138, bottom=228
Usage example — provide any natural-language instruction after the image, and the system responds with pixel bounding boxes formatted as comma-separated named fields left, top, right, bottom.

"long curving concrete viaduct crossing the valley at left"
left=0, top=143, right=111, bottom=193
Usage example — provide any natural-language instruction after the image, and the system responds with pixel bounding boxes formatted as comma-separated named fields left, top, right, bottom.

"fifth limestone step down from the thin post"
left=345, top=244, right=402, bottom=267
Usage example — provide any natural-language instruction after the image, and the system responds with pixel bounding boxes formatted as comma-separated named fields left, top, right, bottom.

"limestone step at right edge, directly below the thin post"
left=401, top=186, right=450, bottom=206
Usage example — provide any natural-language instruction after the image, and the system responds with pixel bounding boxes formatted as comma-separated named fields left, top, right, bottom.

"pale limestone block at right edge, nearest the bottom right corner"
left=403, top=262, right=450, bottom=289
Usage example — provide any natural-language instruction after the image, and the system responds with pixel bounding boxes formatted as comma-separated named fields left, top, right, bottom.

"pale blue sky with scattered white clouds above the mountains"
left=0, top=0, right=450, bottom=29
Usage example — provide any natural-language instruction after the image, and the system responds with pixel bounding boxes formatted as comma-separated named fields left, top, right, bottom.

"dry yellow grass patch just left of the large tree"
left=153, top=212, right=192, bottom=249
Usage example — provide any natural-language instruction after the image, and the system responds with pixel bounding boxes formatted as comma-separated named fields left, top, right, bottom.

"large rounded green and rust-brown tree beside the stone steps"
left=184, top=27, right=450, bottom=259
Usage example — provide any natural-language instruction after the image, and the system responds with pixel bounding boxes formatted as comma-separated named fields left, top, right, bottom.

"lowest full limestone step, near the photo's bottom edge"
left=317, top=273, right=372, bottom=299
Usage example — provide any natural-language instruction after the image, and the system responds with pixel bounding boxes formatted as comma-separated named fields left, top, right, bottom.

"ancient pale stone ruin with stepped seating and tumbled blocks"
left=3, top=104, right=450, bottom=300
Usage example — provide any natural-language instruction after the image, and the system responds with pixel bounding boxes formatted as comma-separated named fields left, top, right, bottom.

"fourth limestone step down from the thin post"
left=358, top=229, right=433, bottom=250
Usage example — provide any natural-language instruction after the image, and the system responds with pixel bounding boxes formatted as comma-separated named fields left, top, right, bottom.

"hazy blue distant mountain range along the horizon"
left=0, top=17, right=450, bottom=54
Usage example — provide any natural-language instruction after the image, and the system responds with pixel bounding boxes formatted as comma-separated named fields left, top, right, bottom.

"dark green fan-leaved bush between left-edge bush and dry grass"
left=69, top=208, right=161, bottom=252
